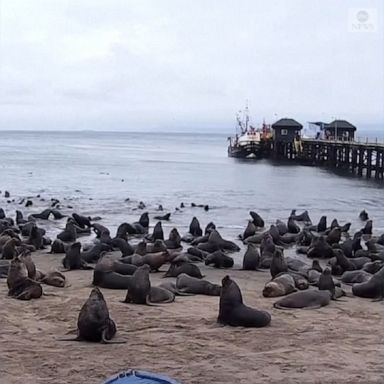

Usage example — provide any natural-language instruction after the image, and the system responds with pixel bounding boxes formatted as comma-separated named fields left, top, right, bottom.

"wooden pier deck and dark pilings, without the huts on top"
left=271, top=139, right=384, bottom=180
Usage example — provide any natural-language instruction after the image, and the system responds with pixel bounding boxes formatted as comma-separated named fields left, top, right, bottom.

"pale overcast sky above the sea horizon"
left=0, top=0, right=384, bottom=131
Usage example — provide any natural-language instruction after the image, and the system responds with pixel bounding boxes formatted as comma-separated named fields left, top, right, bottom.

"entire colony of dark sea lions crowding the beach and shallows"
left=0, top=193, right=384, bottom=343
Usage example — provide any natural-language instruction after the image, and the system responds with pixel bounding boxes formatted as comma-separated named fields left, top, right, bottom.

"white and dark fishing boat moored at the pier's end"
left=228, top=104, right=271, bottom=159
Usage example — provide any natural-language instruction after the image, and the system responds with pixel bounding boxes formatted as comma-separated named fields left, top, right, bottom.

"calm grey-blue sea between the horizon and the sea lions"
left=0, top=131, right=384, bottom=249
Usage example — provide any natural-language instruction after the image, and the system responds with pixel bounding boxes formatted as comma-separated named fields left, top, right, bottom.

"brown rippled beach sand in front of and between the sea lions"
left=0, top=254, right=384, bottom=384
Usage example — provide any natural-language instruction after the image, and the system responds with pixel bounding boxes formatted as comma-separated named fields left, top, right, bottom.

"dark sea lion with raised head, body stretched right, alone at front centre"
left=217, top=275, right=271, bottom=328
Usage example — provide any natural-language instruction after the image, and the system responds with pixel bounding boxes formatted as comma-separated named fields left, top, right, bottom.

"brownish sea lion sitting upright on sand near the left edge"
left=7, top=256, right=43, bottom=300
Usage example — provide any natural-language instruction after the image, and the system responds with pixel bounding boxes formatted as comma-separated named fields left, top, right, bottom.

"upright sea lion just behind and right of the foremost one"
left=123, top=265, right=174, bottom=305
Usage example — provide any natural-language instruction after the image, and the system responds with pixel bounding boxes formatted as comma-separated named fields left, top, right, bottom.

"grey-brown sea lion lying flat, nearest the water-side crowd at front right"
left=273, top=289, right=332, bottom=309
